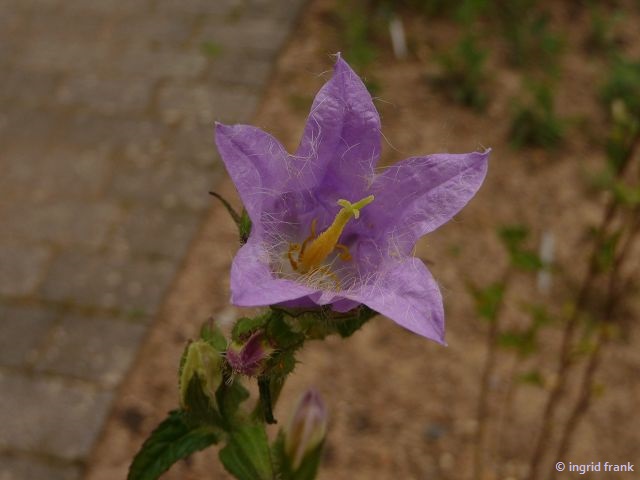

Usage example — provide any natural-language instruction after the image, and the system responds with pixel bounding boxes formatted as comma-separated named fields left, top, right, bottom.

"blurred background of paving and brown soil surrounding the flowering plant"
left=0, top=0, right=640, bottom=480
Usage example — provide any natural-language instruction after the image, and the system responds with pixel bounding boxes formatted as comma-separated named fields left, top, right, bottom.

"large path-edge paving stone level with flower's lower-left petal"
left=42, top=250, right=177, bottom=315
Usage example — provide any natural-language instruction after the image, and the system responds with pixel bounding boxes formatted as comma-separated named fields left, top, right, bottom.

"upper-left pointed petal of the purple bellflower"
left=216, top=123, right=289, bottom=223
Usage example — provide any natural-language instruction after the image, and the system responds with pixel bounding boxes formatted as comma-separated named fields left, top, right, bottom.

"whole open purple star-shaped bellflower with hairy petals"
left=216, top=55, right=489, bottom=343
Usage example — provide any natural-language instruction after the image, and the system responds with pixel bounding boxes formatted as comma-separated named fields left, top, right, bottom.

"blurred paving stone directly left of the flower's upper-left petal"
left=111, top=160, right=219, bottom=211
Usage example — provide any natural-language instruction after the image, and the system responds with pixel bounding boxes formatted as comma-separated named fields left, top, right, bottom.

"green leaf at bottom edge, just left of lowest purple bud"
left=219, top=424, right=274, bottom=480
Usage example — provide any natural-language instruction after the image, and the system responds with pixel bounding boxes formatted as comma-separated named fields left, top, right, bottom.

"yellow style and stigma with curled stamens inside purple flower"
left=294, top=195, right=373, bottom=273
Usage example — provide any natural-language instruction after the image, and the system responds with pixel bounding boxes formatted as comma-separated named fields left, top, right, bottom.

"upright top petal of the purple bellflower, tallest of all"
left=295, top=54, right=380, bottom=200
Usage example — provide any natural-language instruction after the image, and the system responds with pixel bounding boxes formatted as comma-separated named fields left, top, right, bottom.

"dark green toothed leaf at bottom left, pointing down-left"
left=127, top=411, right=219, bottom=480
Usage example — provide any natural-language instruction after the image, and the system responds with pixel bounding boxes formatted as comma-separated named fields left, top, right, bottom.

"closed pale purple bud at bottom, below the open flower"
left=284, top=389, right=327, bottom=471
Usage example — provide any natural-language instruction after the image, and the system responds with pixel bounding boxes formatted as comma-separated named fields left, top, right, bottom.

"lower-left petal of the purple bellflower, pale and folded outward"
left=231, top=232, right=315, bottom=307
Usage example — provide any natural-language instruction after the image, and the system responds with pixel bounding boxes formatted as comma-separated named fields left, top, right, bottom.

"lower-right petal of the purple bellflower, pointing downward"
left=346, top=257, right=445, bottom=344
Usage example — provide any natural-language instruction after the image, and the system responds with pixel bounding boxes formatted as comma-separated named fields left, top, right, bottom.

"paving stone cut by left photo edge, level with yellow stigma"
left=0, top=201, right=121, bottom=249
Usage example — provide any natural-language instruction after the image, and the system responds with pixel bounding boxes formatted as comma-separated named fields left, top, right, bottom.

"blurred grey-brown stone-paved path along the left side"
left=0, top=0, right=304, bottom=480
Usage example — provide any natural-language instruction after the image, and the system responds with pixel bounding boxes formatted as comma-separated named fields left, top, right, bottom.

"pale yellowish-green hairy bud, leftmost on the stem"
left=180, top=340, right=222, bottom=409
